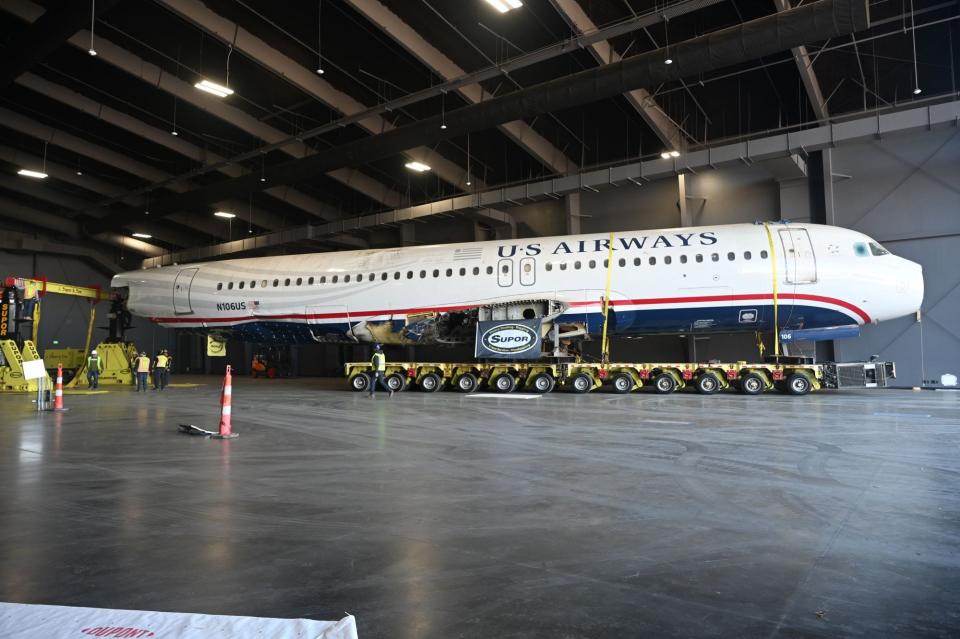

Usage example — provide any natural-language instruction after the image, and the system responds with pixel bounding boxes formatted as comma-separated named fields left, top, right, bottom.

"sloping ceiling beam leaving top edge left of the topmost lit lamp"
left=347, top=0, right=577, bottom=175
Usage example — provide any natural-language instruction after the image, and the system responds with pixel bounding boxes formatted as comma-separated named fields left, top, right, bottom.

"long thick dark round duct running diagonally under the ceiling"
left=92, top=0, right=870, bottom=229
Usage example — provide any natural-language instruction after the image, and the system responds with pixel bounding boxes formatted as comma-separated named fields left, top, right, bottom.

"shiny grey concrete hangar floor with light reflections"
left=0, top=378, right=960, bottom=639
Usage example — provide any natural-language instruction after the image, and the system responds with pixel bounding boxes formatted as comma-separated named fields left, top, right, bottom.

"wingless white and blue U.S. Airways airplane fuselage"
left=113, top=223, right=923, bottom=343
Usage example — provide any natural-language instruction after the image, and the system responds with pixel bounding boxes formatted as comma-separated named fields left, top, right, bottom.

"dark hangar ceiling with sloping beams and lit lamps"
left=0, top=0, right=960, bottom=262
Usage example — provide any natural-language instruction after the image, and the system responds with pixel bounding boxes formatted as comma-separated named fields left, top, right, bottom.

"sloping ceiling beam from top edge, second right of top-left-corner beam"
left=158, top=0, right=477, bottom=191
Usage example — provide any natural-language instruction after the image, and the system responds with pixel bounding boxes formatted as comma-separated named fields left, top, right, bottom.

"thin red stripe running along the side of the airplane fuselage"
left=150, top=293, right=870, bottom=324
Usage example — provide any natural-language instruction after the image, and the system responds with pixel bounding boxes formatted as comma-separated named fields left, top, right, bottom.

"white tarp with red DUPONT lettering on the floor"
left=0, top=602, right=357, bottom=639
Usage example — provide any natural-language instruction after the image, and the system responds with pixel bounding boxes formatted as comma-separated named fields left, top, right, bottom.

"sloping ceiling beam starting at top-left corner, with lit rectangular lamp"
left=0, top=0, right=402, bottom=206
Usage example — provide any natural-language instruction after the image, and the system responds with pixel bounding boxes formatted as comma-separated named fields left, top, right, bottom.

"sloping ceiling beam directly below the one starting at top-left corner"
left=17, top=73, right=340, bottom=220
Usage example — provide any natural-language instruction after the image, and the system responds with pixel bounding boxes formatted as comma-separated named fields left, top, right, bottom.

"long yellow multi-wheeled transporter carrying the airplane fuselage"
left=344, top=361, right=823, bottom=395
